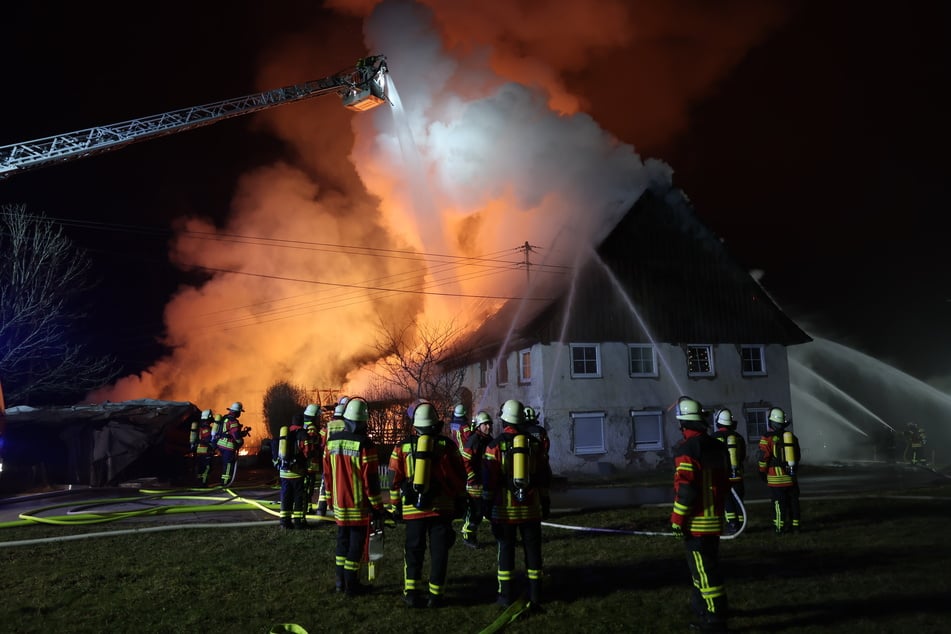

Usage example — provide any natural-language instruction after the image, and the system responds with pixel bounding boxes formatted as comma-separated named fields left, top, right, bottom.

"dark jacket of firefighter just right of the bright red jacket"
left=388, top=435, right=466, bottom=521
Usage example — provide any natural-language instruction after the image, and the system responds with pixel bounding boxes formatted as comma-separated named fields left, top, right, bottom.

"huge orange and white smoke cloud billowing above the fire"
left=91, top=0, right=781, bottom=434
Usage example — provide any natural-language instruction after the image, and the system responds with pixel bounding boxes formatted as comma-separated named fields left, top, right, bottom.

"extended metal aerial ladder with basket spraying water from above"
left=0, top=55, right=389, bottom=180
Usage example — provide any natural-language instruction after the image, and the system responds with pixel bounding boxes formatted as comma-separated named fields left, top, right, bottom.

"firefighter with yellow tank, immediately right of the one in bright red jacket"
left=389, top=403, right=466, bottom=608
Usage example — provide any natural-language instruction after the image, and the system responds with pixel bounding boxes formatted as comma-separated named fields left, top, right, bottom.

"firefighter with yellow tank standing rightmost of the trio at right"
left=759, top=407, right=801, bottom=535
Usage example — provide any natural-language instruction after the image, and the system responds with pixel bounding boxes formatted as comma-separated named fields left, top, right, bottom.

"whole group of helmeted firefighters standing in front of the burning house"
left=193, top=396, right=801, bottom=631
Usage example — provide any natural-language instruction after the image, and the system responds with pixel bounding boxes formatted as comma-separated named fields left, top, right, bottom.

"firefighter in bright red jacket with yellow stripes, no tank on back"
left=323, top=397, right=383, bottom=597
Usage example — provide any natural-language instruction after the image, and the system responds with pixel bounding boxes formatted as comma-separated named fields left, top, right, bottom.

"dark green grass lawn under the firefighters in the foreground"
left=0, top=476, right=951, bottom=634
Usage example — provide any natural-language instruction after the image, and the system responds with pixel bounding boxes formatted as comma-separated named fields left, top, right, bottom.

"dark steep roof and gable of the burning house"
left=458, top=189, right=812, bottom=361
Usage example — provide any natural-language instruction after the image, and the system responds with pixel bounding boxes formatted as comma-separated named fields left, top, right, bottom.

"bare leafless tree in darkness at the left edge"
left=0, top=205, right=118, bottom=405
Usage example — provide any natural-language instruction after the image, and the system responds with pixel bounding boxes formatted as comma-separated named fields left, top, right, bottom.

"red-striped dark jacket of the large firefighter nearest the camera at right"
left=670, top=429, right=730, bottom=537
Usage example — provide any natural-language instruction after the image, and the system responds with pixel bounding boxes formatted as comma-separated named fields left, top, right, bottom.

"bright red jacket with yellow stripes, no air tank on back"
left=324, top=430, right=383, bottom=526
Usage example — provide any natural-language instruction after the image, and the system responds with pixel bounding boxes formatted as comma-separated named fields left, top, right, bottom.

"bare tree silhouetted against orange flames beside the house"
left=375, top=320, right=465, bottom=420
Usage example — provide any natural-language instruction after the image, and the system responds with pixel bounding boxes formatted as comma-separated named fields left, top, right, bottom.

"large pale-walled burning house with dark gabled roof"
left=454, top=189, right=811, bottom=476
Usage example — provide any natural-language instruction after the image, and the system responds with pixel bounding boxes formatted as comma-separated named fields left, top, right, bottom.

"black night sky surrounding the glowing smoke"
left=0, top=1, right=951, bottom=398
